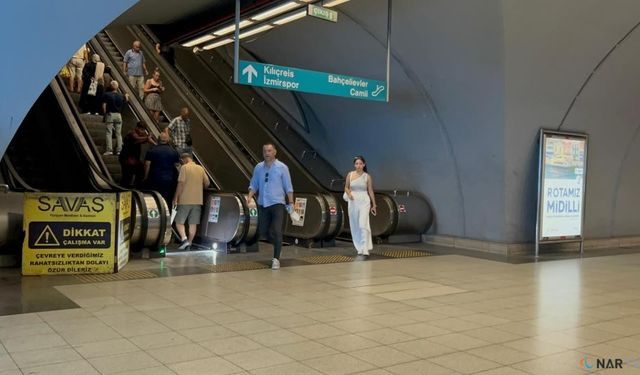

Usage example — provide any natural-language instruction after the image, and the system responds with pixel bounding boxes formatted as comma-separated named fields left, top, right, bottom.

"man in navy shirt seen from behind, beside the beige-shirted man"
left=144, top=133, right=180, bottom=206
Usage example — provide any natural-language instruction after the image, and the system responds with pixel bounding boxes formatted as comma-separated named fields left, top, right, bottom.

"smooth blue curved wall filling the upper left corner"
left=0, top=0, right=137, bottom=159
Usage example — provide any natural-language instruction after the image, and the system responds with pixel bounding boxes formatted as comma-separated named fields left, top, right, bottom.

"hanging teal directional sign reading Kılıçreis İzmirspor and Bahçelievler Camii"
left=238, top=60, right=387, bottom=102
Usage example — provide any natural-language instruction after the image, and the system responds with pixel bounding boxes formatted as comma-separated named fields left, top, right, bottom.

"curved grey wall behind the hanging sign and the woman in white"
left=244, top=0, right=505, bottom=240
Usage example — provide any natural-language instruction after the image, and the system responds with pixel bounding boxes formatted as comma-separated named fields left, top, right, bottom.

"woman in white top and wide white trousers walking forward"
left=343, top=156, right=377, bottom=256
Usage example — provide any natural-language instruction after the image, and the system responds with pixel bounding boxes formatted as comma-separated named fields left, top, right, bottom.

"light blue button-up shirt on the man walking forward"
left=249, top=159, right=293, bottom=207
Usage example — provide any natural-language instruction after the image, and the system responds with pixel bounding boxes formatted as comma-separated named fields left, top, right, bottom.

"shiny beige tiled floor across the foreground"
left=0, top=254, right=640, bottom=375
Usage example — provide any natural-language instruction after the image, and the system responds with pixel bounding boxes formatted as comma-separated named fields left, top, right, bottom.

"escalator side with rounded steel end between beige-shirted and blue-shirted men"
left=94, top=28, right=257, bottom=251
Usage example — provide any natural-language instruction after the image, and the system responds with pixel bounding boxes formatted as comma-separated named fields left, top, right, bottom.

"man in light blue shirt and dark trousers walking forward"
left=247, top=143, right=293, bottom=270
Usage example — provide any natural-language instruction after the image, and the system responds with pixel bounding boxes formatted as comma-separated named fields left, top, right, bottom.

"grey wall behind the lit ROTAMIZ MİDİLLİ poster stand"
left=503, top=0, right=640, bottom=242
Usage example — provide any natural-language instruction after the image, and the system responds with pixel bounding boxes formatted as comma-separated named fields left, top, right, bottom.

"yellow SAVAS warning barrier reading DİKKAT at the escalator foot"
left=22, top=193, right=125, bottom=275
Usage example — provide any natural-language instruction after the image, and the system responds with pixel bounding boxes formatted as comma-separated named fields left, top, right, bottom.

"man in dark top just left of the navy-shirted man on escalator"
left=118, top=121, right=156, bottom=188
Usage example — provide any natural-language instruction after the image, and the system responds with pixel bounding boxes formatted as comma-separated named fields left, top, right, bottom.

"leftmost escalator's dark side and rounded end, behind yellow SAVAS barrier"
left=0, top=77, right=170, bottom=258
